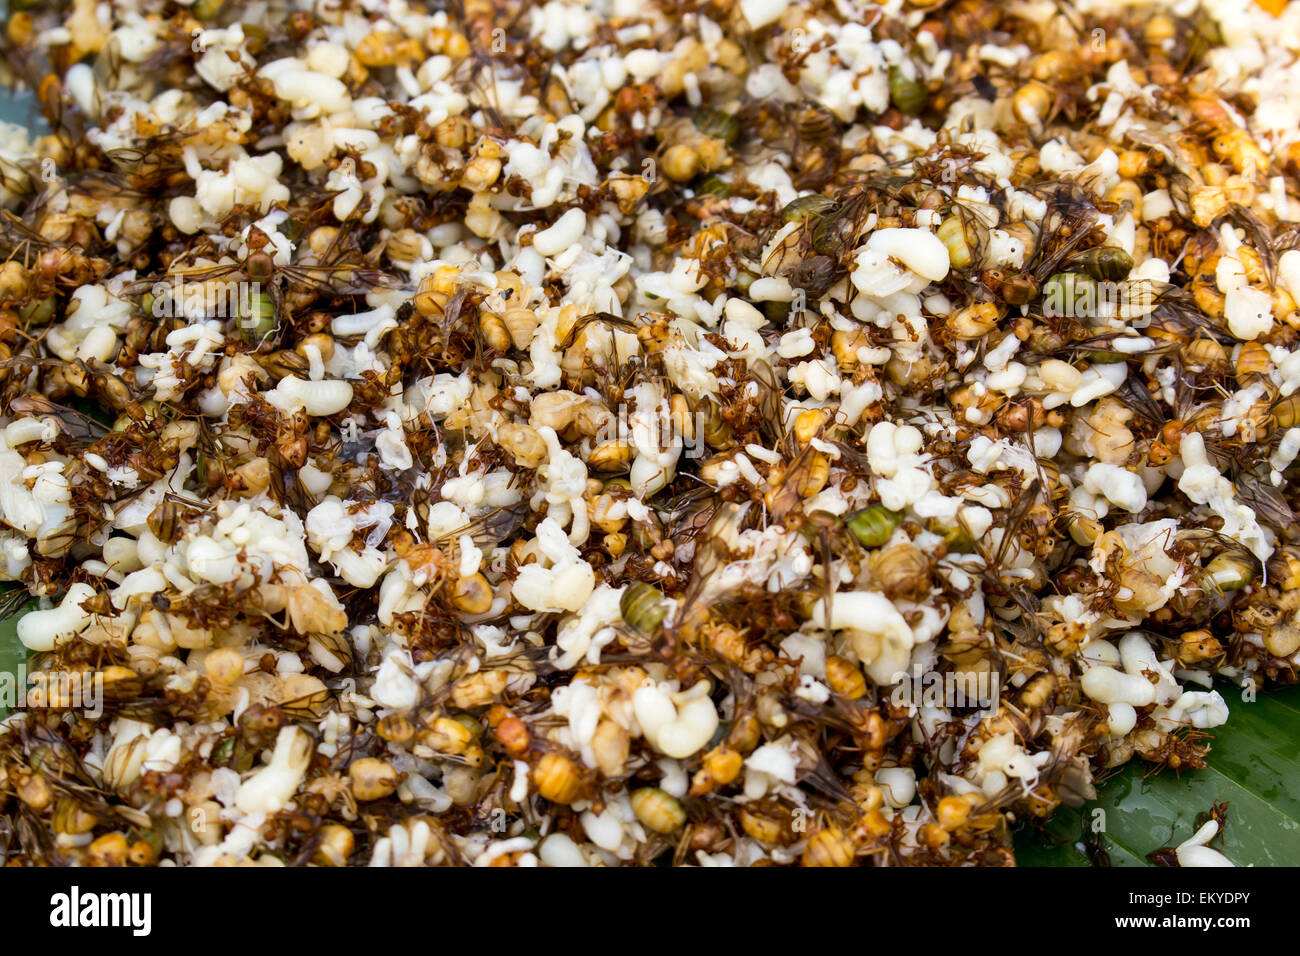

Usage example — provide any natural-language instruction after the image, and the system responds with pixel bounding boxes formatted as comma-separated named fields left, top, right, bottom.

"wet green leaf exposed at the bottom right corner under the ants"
left=1015, top=685, right=1300, bottom=866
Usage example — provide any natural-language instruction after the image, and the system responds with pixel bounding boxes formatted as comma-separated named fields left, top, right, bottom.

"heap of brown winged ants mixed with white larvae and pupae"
left=0, top=0, right=1300, bottom=866
